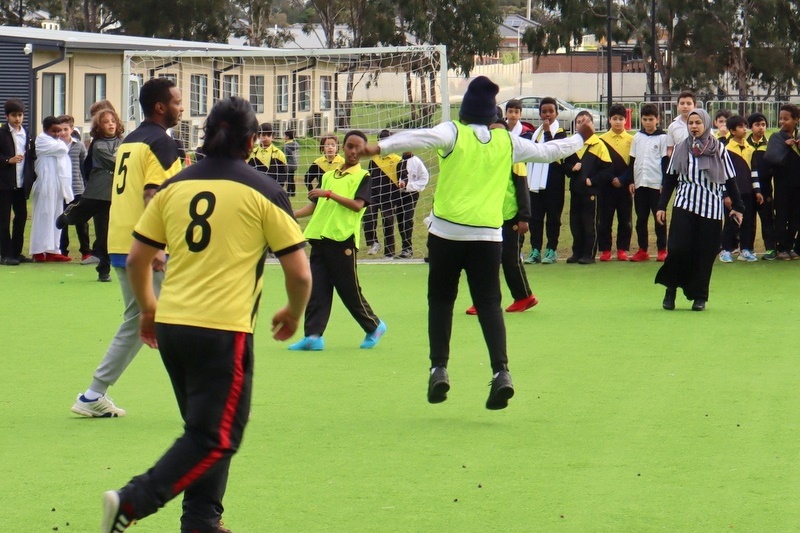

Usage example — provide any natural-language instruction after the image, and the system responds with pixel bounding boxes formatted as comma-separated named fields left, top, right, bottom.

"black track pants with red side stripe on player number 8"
left=120, top=324, right=253, bottom=533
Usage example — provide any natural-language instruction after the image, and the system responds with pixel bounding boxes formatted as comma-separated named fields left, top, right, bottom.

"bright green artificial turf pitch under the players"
left=0, top=261, right=800, bottom=533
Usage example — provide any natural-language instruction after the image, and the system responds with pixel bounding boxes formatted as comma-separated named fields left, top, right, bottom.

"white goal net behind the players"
left=122, top=46, right=450, bottom=259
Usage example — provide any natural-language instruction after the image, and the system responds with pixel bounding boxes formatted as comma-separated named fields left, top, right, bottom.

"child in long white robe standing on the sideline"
left=31, top=116, right=72, bottom=263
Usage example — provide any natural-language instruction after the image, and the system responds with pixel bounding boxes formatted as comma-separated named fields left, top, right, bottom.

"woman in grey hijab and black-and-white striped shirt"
left=655, top=109, right=744, bottom=311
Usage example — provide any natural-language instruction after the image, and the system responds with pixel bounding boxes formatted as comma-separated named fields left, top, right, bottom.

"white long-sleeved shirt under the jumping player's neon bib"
left=378, top=122, right=583, bottom=242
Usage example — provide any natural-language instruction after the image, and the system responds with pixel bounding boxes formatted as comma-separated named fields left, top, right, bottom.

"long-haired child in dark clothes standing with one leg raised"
left=56, top=109, right=124, bottom=282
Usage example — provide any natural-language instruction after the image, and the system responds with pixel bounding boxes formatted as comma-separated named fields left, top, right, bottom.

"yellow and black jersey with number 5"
left=108, top=122, right=181, bottom=254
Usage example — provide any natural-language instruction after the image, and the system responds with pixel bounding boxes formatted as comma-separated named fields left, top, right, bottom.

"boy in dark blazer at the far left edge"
left=0, top=98, right=36, bottom=266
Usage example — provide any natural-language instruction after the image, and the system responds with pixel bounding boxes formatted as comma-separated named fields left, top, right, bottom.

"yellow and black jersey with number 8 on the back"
left=134, top=157, right=305, bottom=333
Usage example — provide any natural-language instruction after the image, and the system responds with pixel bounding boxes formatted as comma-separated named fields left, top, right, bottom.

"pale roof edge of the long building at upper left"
left=0, top=26, right=257, bottom=51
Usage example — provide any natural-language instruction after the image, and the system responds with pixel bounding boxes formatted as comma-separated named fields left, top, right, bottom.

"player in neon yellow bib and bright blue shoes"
left=289, top=131, right=386, bottom=351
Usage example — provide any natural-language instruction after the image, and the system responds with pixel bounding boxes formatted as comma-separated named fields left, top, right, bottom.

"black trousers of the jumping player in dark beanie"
left=428, top=234, right=508, bottom=372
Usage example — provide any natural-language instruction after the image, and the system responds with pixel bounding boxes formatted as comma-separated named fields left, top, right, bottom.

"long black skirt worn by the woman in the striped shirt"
left=655, top=207, right=722, bottom=300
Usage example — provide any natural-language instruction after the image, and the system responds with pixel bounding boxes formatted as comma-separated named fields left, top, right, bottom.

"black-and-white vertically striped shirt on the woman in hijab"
left=670, top=143, right=736, bottom=220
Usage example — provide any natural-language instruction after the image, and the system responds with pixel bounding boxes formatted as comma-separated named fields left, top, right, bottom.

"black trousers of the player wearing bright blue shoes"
left=304, top=237, right=380, bottom=337
